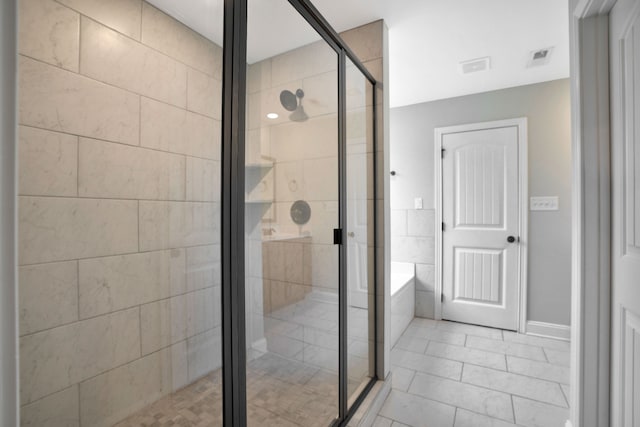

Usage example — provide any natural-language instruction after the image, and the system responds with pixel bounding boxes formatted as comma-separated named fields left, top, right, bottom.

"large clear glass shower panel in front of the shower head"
left=245, top=0, right=339, bottom=426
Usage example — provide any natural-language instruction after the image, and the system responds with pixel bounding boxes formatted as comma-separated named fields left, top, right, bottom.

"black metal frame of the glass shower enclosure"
left=221, top=0, right=381, bottom=427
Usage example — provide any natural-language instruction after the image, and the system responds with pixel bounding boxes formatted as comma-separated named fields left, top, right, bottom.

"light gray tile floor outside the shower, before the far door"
left=374, top=318, right=569, bottom=427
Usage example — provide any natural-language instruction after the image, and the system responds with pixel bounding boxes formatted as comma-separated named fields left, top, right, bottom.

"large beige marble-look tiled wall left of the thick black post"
left=19, top=0, right=222, bottom=426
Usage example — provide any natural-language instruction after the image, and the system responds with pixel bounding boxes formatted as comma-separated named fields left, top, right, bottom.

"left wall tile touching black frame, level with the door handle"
left=140, top=201, right=220, bottom=251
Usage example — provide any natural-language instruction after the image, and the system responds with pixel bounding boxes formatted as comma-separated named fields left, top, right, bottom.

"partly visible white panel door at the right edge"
left=608, top=0, right=640, bottom=427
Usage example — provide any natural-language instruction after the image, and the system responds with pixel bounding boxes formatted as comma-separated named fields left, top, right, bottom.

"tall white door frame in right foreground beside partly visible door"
left=569, top=0, right=616, bottom=427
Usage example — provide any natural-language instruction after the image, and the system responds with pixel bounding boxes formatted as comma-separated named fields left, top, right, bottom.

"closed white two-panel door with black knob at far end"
left=441, top=124, right=520, bottom=330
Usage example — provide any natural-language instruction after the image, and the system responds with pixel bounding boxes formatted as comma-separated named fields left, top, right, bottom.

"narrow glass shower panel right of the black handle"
left=345, top=59, right=375, bottom=406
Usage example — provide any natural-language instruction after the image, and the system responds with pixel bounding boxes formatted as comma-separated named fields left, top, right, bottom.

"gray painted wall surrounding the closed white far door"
left=391, top=79, right=571, bottom=325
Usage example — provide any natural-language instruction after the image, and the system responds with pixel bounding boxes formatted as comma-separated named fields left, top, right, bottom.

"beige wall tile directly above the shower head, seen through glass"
left=271, top=42, right=338, bottom=91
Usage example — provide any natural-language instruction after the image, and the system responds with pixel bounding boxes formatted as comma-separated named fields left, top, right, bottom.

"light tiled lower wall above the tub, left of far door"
left=391, top=209, right=435, bottom=319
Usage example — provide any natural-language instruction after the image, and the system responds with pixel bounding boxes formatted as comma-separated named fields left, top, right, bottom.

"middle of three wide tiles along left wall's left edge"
left=18, top=196, right=138, bottom=265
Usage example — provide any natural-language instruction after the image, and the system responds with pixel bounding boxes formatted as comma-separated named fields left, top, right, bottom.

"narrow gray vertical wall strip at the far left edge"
left=0, top=0, right=18, bottom=427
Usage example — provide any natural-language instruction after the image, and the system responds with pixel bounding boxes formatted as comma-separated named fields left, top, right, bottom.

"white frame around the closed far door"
left=433, top=117, right=529, bottom=333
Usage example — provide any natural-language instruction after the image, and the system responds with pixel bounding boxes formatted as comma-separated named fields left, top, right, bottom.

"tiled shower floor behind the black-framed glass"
left=117, top=294, right=369, bottom=427
